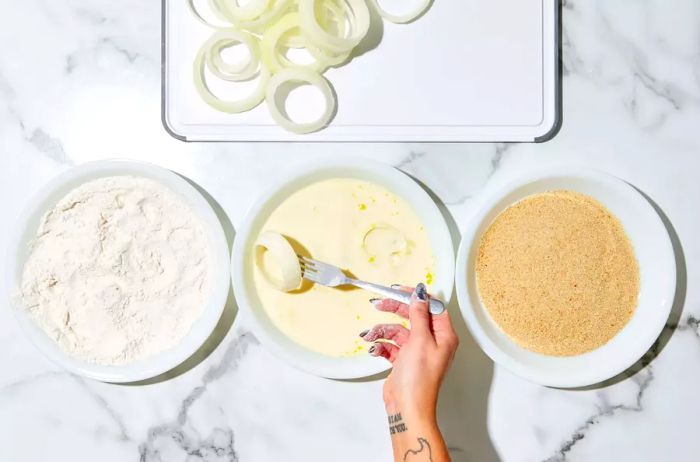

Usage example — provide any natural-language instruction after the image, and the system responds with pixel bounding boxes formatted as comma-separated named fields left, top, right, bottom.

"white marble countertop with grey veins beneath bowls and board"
left=0, top=0, right=700, bottom=462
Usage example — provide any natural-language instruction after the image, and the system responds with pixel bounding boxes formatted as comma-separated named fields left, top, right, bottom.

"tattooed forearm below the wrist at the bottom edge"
left=389, top=412, right=450, bottom=462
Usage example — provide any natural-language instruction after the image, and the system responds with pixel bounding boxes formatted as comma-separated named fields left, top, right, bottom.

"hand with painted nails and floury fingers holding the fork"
left=360, top=283, right=459, bottom=422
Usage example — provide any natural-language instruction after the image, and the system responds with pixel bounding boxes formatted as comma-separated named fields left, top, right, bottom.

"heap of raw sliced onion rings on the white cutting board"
left=186, top=0, right=431, bottom=134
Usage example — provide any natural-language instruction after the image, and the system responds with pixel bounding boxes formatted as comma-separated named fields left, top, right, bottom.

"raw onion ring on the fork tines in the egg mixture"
left=255, top=231, right=301, bottom=292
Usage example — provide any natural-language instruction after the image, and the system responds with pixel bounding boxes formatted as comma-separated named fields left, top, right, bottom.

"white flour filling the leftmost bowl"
left=21, top=176, right=211, bottom=365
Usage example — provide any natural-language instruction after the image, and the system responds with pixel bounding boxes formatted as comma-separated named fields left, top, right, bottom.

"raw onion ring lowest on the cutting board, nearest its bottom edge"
left=265, top=68, right=337, bottom=134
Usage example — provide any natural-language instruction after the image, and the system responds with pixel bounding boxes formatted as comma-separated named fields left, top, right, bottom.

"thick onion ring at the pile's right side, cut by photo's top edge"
left=299, top=0, right=370, bottom=53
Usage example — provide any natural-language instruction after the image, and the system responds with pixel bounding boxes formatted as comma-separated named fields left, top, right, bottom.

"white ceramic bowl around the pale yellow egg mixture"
left=231, top=158, right=454, bottom=379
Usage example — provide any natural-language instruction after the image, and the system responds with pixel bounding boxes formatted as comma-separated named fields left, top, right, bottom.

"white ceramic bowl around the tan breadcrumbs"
left=455, top=170, right=676, bottom=388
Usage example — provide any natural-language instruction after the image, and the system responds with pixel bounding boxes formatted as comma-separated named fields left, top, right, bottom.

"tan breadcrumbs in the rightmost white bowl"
left=476, top=190, right=640, bottom=356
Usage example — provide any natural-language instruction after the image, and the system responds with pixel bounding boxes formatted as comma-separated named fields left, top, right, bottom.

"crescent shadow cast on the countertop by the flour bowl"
left=122, top=174, right=238, bottom=386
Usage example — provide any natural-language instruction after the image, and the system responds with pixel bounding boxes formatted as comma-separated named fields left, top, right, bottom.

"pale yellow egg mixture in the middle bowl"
left=250, top=178, right=433, bottom=356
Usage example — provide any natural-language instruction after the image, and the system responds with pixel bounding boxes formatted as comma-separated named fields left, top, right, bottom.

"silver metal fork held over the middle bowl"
left=297, top=255, right=445, bottom=314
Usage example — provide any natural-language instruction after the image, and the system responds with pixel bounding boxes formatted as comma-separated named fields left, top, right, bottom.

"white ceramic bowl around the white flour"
left=7, top=160, right=230, bottom=382
